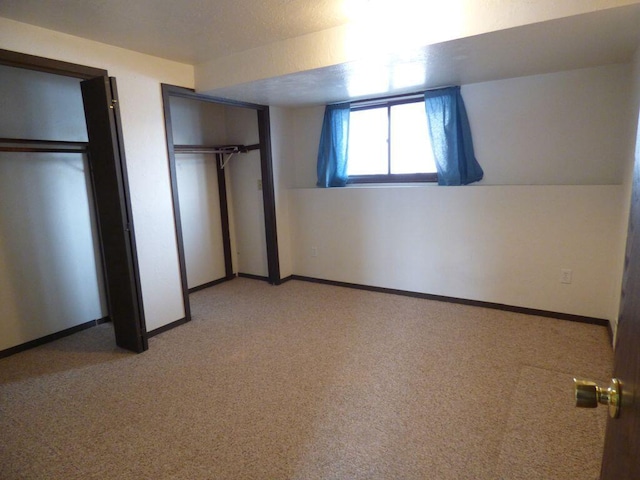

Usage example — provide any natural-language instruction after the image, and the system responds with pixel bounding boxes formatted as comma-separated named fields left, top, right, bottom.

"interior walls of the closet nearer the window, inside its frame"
left=169, top=96, right=268, bottom=290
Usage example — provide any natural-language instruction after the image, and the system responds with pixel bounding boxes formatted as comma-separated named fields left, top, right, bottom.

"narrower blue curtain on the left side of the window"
left=317, top=103, right=351, bottom=187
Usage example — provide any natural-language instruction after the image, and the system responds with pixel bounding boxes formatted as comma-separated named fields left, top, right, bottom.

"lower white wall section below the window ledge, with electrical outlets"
left=291, top=186, right=622, bottom=318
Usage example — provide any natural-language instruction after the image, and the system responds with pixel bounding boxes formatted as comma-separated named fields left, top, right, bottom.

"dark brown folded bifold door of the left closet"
left=80, top=77, right=149, bottom=353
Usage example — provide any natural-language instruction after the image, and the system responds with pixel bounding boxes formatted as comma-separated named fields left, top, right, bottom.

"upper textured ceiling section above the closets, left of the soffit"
left=0, top=0, right=348, bottom=64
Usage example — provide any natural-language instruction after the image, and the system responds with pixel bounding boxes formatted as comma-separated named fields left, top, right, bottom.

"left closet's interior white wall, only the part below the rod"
left=0, top=153, right=107, bottom=351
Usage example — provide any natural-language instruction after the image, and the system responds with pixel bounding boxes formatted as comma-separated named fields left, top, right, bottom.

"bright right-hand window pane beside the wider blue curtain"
left=391, top=102, right=436, bottom=173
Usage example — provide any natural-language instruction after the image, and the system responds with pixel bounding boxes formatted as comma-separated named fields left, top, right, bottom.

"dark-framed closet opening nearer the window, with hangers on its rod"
left=160, top=84, right=281, bottom=328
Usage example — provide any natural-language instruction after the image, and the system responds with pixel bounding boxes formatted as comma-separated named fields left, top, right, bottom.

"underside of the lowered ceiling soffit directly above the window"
left=204, top=4, right=640, bottom=106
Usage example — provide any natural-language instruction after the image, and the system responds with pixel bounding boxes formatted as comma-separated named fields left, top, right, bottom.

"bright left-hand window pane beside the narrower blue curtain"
left=347, top=107, right=389, bottom=175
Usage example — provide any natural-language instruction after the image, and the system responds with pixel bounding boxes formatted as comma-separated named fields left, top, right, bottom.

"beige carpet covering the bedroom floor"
left=0, top=279, right=612, bottom=480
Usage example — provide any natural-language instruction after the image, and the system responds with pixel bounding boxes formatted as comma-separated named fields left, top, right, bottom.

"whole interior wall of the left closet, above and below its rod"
left=0, top=65, right=108, bottom=351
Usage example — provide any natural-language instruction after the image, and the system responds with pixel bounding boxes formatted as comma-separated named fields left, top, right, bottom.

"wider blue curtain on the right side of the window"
left=424, top=87, right=484, bottom=185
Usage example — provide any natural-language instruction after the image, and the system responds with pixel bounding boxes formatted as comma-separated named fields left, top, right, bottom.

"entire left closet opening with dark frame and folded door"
left=0, top=50, right=148, bottom=357
